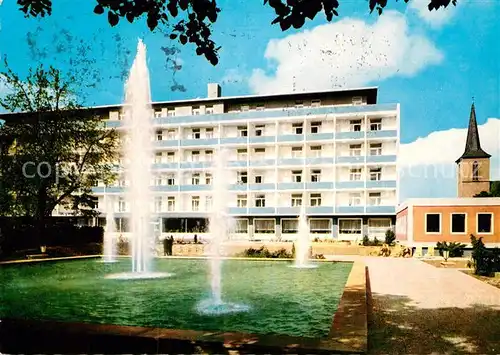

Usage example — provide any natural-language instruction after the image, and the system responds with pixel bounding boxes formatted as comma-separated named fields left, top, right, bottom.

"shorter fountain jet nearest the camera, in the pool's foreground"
left=197, top=150, right=249, bottom=315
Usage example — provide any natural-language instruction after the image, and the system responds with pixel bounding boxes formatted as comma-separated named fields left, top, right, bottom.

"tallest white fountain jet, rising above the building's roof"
left=108, top=40, right=171, bottom=279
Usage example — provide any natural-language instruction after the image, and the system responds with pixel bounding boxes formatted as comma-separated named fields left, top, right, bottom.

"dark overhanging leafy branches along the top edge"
left=17, top=0, right=458, bottom=65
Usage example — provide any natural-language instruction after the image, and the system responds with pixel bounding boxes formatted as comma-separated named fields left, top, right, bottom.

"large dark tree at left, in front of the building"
left=0, top=60, right=118, bottom=242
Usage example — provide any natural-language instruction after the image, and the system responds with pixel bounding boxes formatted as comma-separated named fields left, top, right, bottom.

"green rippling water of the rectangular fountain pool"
left=0, top=259, right=352, bottom=337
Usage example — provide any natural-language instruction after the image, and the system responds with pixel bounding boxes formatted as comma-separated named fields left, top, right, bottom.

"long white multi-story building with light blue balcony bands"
left=94, top=84, right=400, bottom=240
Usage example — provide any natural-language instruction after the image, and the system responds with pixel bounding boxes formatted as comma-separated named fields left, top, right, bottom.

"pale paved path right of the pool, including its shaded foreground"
left=365, top=258, right=500, bottom=354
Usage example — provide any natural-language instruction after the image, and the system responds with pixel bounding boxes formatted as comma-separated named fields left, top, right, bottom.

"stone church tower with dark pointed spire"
left=456, top=103, right=491, bottom=197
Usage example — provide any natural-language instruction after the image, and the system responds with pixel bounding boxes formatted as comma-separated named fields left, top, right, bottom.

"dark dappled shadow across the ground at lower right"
left=367, top=268, right=500, bottom=354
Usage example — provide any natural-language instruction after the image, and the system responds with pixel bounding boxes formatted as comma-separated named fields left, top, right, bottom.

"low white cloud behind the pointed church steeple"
left=398, top=118, right=500, bottom=202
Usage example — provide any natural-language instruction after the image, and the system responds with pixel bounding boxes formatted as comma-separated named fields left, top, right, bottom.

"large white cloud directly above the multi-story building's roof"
left=249, top=11, right=443, bottom=94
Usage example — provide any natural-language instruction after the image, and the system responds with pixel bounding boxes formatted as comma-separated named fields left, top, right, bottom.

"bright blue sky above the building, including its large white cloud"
left=0, top=0, right=500, bottom=197
